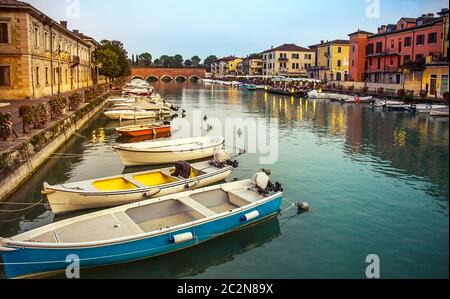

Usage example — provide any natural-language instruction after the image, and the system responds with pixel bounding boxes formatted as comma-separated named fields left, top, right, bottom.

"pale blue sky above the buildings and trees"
left=27, top=0, right=448, bottom=59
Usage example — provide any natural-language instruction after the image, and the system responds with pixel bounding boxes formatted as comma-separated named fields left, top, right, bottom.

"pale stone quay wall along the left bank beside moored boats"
left=0, top=94, right=108, bottom=202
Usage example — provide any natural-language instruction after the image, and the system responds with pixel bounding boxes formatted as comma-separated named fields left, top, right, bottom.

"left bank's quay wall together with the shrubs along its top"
left=0, top=91, right=110, bottom=201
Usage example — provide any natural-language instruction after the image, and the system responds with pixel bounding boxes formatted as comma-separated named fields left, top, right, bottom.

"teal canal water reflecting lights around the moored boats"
left=0, top=82, right=449, bottom=279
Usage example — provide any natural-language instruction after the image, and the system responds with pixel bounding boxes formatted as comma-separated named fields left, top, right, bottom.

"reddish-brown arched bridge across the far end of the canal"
left=130, top=68, right=206, bottom=82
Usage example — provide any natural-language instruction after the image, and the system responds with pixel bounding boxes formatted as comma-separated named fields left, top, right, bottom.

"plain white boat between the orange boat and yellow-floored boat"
left=114, top=137, right=225, bottom=166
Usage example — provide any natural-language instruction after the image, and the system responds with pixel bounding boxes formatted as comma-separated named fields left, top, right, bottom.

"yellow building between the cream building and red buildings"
left=308, top=40, right=350, bottom=81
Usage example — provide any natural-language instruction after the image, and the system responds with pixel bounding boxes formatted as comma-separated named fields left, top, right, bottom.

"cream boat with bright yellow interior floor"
left=42, top=162, right=233, bottom=214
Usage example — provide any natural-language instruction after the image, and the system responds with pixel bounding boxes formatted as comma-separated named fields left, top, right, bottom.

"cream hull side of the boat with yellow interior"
left=44, top=170, right=231, bottom=215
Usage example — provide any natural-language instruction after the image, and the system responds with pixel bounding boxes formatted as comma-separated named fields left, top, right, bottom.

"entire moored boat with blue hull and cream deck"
left=0, top=180, right=283, bottom=278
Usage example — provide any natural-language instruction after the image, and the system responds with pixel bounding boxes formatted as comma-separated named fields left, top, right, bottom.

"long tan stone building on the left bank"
left=0, top=0, right=97, bottom=99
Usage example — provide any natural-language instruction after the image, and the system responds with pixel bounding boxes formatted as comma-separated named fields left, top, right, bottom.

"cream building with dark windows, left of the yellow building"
left=262, top=44, right=316, bottom=78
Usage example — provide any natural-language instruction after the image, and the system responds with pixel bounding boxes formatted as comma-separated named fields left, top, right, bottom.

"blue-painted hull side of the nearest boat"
left=0, top=195, right=282, bottom=278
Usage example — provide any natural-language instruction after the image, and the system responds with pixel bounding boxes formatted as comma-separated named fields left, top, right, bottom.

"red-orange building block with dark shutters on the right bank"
left=349, top=9, right=448, bottom=97
